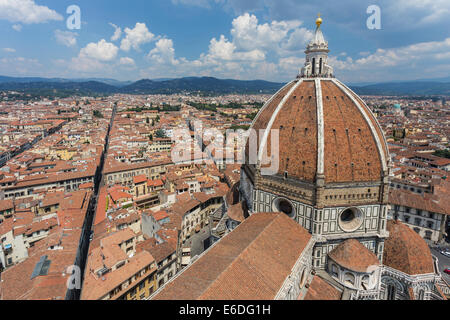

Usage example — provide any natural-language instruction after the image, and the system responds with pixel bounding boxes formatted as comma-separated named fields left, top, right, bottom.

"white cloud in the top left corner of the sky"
left=0, top=0, right=63, bottom=24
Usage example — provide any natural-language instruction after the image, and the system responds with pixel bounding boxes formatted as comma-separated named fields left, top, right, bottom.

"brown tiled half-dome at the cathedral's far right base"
left=383, top=220, right=434, bottom=275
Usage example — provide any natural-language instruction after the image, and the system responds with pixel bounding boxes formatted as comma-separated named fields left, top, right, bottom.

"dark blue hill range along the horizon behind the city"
left=0, top=76, right=450, bottom=96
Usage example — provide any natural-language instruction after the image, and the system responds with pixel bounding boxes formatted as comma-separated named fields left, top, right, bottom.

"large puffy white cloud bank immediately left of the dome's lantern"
left=141, top=13, right=312, bottom=79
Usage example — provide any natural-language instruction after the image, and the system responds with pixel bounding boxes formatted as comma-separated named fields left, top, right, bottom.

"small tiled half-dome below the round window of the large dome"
left=328, top=239, right=380, bottom=273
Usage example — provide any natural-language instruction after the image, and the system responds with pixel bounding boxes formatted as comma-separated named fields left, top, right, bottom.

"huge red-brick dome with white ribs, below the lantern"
left=246, top=74, right=389, bottom=183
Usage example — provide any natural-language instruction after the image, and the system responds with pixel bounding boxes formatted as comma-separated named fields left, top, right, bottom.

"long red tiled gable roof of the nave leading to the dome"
left=155, top=213, right=311, bottom=300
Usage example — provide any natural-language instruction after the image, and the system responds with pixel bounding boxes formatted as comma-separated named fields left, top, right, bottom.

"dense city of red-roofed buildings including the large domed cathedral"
left=0, top=13, right=450, bottom=300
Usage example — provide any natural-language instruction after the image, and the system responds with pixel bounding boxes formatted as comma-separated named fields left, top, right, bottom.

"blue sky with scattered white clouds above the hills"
left=0, top=0, right=450, bottom=83
